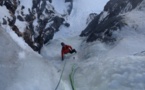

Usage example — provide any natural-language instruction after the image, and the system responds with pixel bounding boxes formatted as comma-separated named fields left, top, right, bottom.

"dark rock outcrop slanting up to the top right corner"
left=80, top=0, right=143, bottom=42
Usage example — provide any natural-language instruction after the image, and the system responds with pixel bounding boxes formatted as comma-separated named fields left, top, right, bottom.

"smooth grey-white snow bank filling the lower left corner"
left=0, top=27, right=65, bottom=90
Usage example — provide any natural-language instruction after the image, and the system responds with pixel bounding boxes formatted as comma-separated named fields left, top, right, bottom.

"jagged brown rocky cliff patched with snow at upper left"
left=0, top=0, right=73, bottom=52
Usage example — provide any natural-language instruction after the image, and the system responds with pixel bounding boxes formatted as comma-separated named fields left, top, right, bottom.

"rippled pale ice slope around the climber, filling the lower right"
left=42, top=28, right=145, bottom=90
